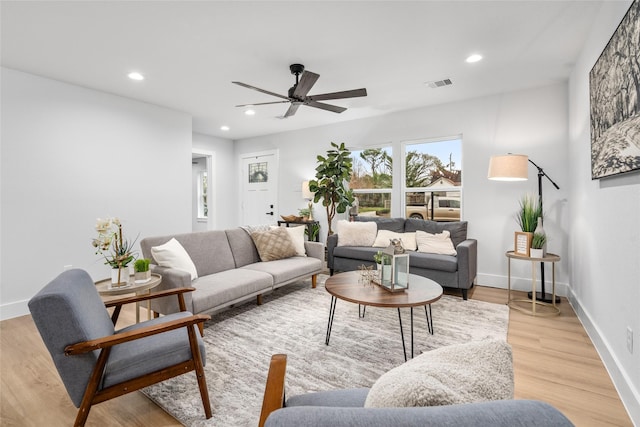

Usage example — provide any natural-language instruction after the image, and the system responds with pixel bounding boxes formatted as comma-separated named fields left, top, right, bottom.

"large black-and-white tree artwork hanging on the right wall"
left=589, top=0, right=640, bottom=179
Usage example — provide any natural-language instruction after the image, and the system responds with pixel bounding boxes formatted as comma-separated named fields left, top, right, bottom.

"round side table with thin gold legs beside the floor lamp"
left=505, top=251, right=560, bottom=316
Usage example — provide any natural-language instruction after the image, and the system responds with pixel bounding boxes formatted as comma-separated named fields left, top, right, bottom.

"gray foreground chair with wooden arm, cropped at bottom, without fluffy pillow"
left=258, top=354, right=573, bottom=427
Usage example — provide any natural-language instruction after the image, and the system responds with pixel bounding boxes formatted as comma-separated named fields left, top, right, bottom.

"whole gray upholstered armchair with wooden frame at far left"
left=29, top=269, right=211, bottom=426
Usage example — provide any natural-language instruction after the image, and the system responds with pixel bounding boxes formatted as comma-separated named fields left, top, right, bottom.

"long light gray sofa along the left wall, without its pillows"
left=140, top=228, right=324, bottom=314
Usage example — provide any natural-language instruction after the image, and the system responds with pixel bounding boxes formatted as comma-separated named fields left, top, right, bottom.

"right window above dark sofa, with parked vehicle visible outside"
left=404, top=138, right=462, bottom=221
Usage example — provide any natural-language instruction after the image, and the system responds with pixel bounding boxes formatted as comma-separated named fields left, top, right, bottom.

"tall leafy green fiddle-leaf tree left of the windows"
left=309, top=142, right=354, bottom=236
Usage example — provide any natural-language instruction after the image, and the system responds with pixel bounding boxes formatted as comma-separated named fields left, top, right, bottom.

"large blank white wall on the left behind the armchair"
left=0, top=68, right=191, bottom=319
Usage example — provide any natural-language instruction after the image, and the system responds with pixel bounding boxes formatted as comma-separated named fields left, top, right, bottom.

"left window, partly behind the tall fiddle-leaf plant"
left=349, top=147, right=393, bottom=217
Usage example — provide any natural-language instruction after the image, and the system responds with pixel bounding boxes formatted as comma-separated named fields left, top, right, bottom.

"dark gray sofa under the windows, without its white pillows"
left=327, top=216, right=478, bottom=300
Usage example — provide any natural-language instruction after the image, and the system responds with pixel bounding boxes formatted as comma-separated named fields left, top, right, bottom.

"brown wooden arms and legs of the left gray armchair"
left=64, top=288, right=211, bottom=426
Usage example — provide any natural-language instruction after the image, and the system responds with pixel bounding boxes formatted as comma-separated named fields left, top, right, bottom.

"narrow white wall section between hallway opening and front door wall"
left=193, top=133, right=240, bottom=230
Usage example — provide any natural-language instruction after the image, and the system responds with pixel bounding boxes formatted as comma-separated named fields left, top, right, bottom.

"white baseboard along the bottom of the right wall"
left=568, top=291, right=640, bottom=426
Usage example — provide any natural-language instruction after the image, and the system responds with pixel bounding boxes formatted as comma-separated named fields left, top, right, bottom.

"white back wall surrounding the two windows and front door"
left=237, top=83, right=569, bottom=293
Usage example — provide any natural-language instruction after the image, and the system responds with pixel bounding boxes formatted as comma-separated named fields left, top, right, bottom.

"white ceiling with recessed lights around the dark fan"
left=0, top=0, right=602, bottom=139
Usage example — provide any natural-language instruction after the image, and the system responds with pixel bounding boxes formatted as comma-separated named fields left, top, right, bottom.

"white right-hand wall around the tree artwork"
left=567, top=1, right=640, bottom=425
